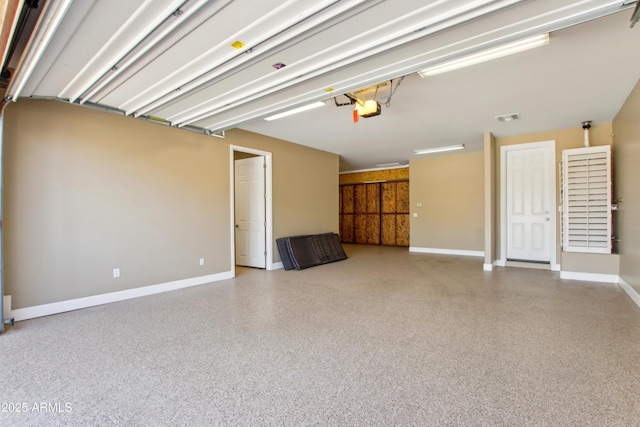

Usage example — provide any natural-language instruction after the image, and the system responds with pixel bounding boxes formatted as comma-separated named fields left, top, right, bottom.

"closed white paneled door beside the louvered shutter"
left=506, top=147, right=555, bottom=263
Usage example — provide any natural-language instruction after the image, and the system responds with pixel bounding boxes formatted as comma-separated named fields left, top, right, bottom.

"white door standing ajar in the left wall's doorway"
left=234, top=156, right=266, bottom=268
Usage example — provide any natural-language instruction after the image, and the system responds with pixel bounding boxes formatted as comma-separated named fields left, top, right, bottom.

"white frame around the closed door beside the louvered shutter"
left=497, top=140, right=560, bottom=271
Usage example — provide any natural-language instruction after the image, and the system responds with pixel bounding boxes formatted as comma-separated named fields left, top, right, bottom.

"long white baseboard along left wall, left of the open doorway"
left=11, top=271, right=234, bottom=321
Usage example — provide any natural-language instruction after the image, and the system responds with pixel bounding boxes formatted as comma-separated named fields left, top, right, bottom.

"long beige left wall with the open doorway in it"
left=3, top=100, right=338, bottom=309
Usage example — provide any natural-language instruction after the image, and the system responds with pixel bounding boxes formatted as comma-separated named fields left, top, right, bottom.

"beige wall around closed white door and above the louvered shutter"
left=495, top=123, right=615, bottom=268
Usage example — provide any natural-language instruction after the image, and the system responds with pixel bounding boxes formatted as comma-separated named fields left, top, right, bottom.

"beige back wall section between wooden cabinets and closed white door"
left=409, top=152, right=484, bottom=251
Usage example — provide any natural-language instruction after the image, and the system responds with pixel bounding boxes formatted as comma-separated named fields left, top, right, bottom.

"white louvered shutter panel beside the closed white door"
left=562, top=145, right=611, bottom=254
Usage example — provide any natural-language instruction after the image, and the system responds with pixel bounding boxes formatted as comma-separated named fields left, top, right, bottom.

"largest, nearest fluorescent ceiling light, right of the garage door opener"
left=418, top=33, right=549, bottom=78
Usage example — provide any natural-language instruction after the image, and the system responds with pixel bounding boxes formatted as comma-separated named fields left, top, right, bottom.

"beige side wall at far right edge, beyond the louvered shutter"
left=613, top=77, right=640, bottom=293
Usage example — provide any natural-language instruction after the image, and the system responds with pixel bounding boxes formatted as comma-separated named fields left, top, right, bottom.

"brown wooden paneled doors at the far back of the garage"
left=339, top=181, right=409, bottom=246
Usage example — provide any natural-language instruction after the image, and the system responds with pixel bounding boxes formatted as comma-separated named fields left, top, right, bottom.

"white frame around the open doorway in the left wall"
left=229, top=145, right=276, bottom=270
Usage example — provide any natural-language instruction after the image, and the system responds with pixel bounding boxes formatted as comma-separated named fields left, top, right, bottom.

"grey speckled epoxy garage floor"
left=0, top=246, right=640, bottom=426
